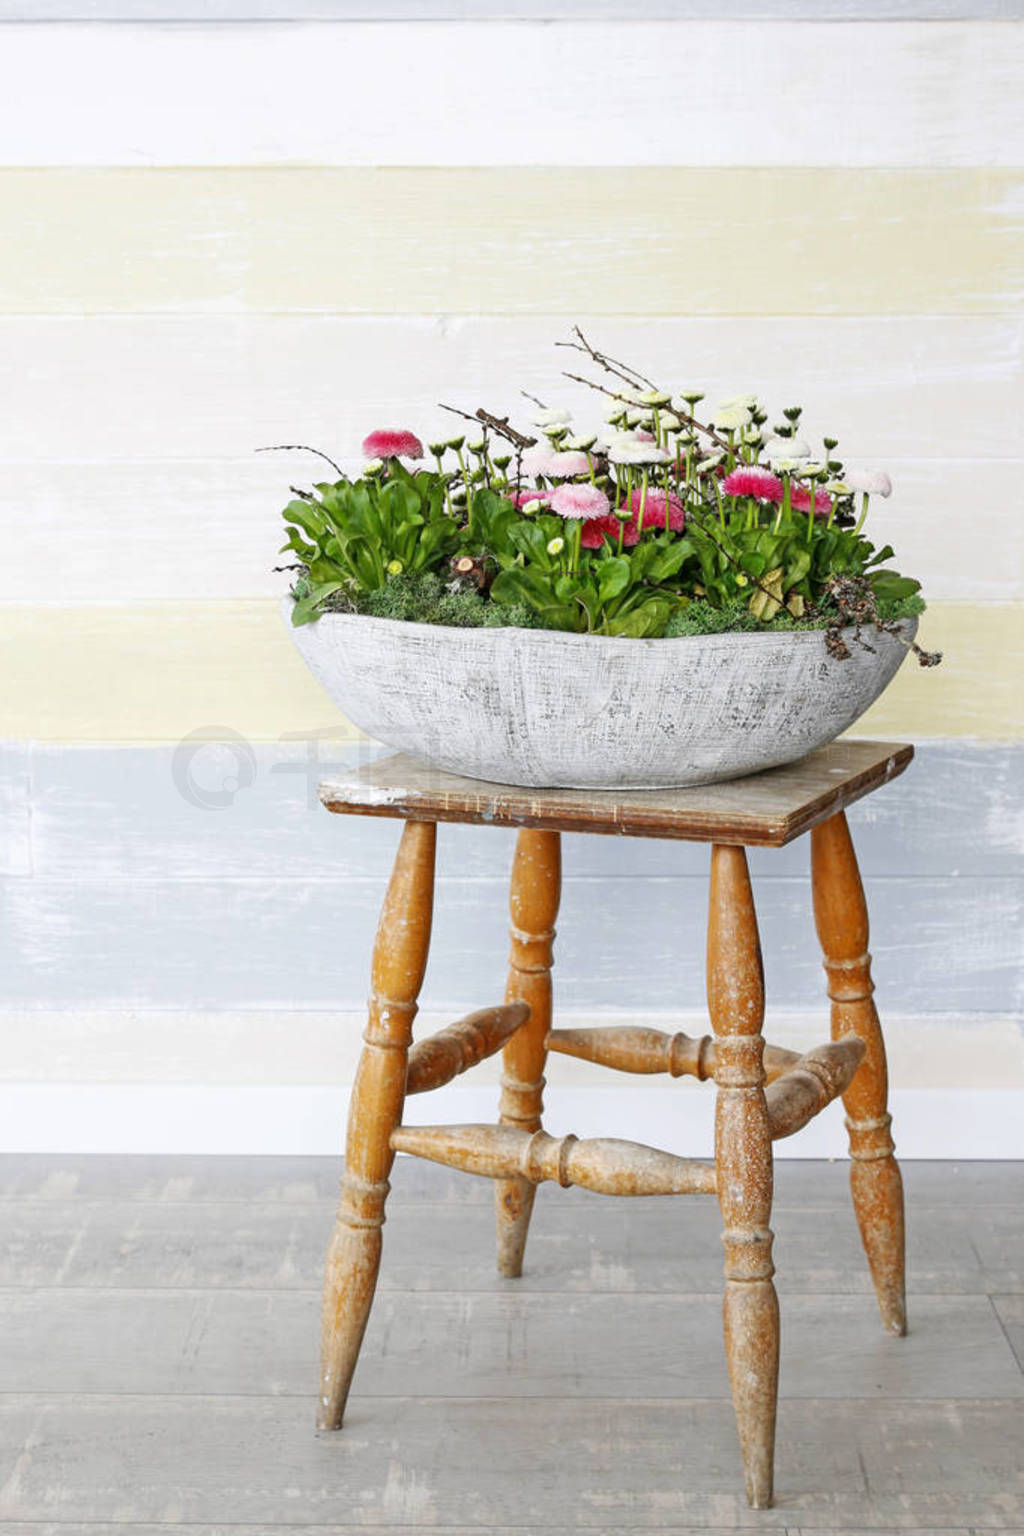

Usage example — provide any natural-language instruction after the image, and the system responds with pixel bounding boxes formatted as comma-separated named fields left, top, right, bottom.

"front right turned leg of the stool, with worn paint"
left=708, top=846, right=778, bottom=1510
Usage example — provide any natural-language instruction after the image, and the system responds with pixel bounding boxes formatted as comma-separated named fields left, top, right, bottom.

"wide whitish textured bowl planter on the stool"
left=286, top=602, right=917, bottom=790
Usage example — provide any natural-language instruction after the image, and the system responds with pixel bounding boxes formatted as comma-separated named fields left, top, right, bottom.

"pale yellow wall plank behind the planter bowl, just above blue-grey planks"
left=0, top=599, right=1024, bottom=740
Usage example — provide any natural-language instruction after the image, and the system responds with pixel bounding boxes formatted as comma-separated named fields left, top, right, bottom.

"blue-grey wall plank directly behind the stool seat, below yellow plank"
left=22, top=737, right=1024, bottom=882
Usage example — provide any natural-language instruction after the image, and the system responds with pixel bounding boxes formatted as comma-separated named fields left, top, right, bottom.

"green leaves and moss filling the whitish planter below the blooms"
left=282, top=459, right=923, bottom=637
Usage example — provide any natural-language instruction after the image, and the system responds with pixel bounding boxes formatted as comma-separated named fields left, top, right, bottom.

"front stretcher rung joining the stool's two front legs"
left=391, top=1126, right=717, bottom=1195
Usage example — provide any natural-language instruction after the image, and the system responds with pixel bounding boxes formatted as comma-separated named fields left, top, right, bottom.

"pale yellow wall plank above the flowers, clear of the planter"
left=0, top=166, right=1024, bottom=316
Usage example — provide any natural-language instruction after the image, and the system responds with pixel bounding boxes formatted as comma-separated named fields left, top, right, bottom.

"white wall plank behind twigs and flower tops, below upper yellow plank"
left=0, top=315, right=1024, bottom=457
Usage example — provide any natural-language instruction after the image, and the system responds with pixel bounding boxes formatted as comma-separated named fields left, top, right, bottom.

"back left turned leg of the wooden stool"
left=494, top=828, right=562, bottom=1278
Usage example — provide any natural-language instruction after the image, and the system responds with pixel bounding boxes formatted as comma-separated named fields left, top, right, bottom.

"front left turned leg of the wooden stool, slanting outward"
left=316, top=822, right=436, bottom=1430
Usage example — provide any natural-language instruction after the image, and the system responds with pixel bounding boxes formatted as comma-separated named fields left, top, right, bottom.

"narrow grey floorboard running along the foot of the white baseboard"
left=8, top=1154, right=1024, bottom=1213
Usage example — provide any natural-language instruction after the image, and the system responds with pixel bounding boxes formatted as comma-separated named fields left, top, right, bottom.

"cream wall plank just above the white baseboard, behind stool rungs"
left=0, top=1007, right=1024, bottom=1105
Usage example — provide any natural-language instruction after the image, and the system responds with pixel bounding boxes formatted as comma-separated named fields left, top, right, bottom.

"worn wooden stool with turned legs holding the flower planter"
left=318, top=740, right=912, bottom=1508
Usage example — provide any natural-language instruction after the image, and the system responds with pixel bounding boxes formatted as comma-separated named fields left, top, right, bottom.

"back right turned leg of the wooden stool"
left=811, top=811, right=907, bottom=1333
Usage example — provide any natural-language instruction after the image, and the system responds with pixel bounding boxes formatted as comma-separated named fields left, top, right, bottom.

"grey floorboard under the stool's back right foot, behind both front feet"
left=0, top=1284, right=1024, bottom=1401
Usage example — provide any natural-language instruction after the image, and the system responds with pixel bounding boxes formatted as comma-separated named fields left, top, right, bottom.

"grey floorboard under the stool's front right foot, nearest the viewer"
left=0, top=1396, right=1024, bottom=1530
